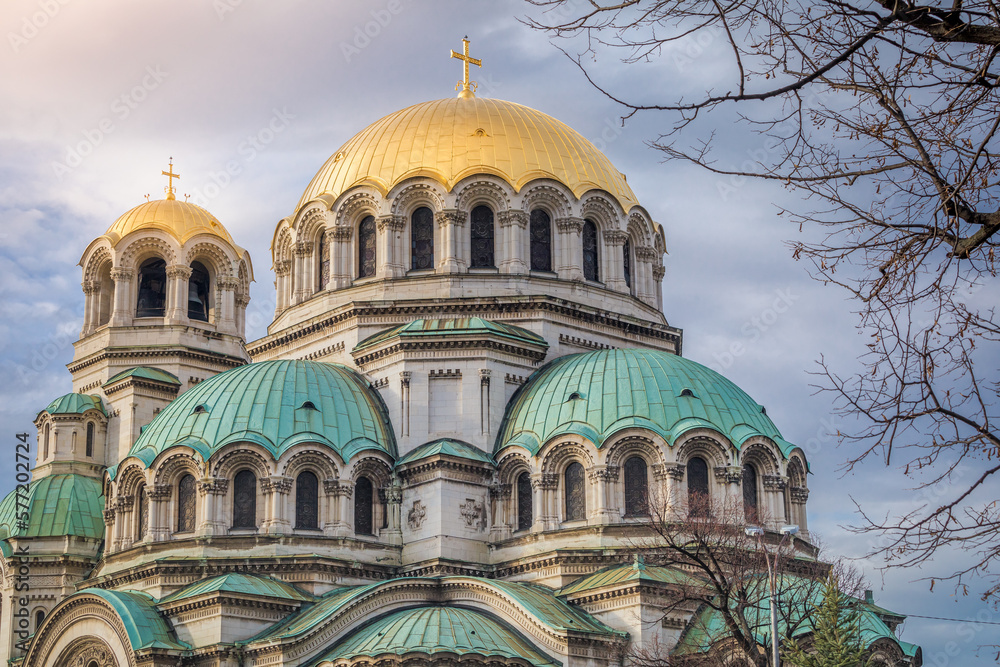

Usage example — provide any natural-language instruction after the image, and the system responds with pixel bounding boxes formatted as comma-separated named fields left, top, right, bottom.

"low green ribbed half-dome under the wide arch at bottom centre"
left=320, top=607, right=562, bottom=666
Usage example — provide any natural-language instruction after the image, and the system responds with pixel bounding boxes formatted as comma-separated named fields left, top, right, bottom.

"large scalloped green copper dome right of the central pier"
left=495, top=349, right=794, bottom=456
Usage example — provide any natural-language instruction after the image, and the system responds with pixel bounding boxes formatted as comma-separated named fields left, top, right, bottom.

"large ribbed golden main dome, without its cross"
left=296, top=97, right=636, bottom=211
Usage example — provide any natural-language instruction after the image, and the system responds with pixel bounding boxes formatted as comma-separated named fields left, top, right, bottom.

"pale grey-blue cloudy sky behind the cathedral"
left=0, top=0, right=1000, bottom=665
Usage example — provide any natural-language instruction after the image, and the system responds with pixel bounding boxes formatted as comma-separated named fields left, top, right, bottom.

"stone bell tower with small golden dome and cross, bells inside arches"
left=69, top=159, right=253, bottom=465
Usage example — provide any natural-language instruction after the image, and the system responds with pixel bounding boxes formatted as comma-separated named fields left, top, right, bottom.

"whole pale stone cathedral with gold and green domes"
left=0, top=42, right=921, bottom=667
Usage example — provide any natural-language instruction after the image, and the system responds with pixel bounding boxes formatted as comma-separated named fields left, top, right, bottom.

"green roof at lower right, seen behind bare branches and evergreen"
left=673, top=575, right=919, bottom=655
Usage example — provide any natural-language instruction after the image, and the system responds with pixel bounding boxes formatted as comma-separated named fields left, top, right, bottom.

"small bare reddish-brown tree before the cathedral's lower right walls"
left=630, top=497, right=863, bottom=667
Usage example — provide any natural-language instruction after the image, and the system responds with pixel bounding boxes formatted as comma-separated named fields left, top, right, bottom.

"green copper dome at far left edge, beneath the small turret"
left=0, top=474, right=104, bottom=540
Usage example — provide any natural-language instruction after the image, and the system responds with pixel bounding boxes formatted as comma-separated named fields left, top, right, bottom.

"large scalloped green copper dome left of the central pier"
left=127, top=360, right=396, bottom=477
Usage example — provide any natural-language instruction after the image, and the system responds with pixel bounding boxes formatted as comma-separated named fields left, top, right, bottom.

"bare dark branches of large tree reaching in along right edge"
left=525, top=0, right=1000, bottom=602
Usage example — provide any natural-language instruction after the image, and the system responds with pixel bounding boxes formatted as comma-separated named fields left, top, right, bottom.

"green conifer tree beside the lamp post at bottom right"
left=781, top=574, right=867, bottom=667
